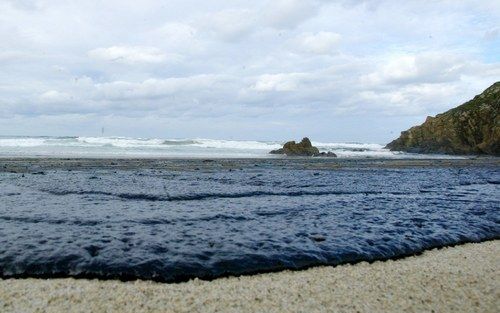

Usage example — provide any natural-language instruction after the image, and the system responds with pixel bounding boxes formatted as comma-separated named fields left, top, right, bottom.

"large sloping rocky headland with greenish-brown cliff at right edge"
left=386, top=82, right=500, bottom=156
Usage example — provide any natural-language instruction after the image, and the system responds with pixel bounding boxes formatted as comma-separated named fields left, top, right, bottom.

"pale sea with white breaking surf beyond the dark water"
left=0, top=137, right=458, bottom=159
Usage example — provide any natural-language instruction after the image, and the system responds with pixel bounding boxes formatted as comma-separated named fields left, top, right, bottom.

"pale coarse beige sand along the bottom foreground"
left=0, top=240, right=500, bottom=312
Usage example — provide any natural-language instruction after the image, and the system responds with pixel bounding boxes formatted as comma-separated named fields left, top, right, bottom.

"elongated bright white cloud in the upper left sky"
left=88, top=46, right=167, bottom=64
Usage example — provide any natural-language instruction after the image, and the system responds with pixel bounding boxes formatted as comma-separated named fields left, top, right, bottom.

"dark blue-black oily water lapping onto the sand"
left=0, top=158, right=500, bottom=282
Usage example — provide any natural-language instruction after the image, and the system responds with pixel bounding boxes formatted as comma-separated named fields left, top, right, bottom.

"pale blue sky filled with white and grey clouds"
left=0, top=0, right=500, bottom=143
